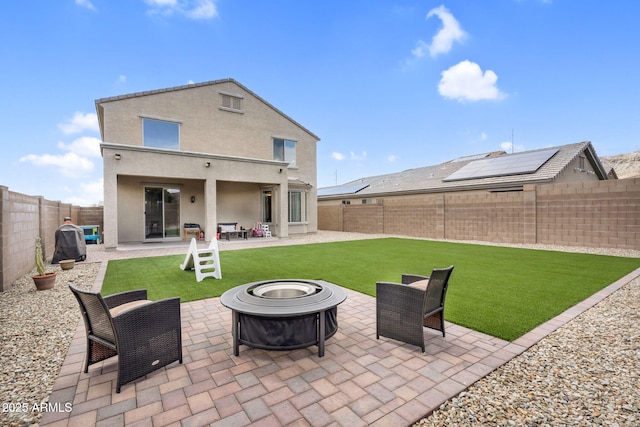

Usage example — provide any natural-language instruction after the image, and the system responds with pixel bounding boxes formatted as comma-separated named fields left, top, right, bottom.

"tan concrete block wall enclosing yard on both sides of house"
left=0, top=178, right=640, bottom=291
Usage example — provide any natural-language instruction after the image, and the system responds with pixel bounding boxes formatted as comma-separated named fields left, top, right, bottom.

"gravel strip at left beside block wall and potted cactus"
left=0, top=263, right=100, bottom=426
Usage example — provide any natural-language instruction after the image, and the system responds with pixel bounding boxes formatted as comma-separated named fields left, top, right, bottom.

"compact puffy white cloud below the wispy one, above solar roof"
left=438, top=60, right=505, bottom=101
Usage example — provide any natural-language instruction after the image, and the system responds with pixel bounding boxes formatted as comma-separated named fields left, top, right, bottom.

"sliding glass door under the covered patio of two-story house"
left=144, top=187, right=180, bottom=241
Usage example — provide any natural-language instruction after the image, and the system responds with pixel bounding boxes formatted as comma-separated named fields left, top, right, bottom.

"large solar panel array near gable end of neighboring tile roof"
left=443, top=148, right=558, bottom=182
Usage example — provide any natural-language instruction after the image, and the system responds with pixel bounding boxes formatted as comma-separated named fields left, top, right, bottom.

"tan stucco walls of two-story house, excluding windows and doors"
left=98, top=81, right=318, bottom=247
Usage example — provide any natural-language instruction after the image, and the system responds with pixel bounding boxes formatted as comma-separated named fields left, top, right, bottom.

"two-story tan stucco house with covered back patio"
left=95, top=79, right=319, bottom=248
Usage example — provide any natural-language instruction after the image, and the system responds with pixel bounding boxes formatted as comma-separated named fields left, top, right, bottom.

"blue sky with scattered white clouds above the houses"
left=0, top=0, right=640, bottom=206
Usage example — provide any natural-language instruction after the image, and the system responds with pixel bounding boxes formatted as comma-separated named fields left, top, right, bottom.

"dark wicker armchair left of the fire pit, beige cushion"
left=69, top=285, right=182, bottom=393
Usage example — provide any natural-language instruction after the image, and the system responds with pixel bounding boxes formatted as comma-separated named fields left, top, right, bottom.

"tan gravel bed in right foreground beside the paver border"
left=415, top=278, right=640, bottom=426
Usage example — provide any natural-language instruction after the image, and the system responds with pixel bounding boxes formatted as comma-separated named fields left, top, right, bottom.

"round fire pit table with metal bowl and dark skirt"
left=220, top=279, right=347, bottom=357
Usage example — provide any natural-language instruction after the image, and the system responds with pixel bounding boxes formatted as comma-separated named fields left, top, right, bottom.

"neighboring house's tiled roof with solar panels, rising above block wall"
left=318, top=142, right=615, bottom=201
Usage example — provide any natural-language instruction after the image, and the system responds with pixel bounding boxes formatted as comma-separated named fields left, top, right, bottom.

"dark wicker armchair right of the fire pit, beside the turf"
left=376, top=265, right=453, bottom=353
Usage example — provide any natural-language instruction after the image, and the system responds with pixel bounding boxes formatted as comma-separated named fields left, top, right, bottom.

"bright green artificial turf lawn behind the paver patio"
left=102, top=238, right=640, bottom=341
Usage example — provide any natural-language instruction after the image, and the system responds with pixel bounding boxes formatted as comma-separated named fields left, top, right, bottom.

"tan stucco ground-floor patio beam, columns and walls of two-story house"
left=103, top=145, right=288, bottom=247
